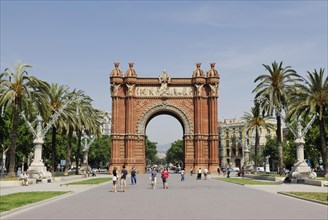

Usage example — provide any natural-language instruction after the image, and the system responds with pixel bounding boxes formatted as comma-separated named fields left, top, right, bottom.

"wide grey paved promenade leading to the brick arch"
left=1, top=174, right=328, bottom=220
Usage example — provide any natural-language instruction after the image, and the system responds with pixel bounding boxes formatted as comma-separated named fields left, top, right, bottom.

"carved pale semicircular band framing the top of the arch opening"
left=137, top=103, right=193, bottom=135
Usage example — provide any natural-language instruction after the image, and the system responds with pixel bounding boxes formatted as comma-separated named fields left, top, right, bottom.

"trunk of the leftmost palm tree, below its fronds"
left=8, top=99, right=19, bottom=177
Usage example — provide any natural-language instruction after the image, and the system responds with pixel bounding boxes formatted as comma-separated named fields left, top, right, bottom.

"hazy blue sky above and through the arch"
left=0, top=0, right=328, bottom=144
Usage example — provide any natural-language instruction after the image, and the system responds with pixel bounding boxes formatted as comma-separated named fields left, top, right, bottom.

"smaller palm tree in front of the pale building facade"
left=242, top=103, right=274, bottom=170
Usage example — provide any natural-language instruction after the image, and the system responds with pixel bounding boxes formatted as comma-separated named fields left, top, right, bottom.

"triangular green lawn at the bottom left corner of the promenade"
left=0, top=191, right=68, bottom=212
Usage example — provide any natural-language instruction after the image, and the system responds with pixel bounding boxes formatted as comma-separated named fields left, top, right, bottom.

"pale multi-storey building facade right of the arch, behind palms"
left=219, top=118, right=276, bottom=168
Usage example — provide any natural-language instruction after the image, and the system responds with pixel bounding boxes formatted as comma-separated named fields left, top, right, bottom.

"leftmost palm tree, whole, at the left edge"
left=0, top=61, right=47, bottom=176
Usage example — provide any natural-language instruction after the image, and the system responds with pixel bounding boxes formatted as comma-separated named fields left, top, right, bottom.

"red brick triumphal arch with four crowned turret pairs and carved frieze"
left=110, top=63, right=220, bottom=173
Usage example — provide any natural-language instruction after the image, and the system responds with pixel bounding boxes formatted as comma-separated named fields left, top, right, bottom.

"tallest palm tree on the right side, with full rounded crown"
left=253, top=61, right=300, bottom=175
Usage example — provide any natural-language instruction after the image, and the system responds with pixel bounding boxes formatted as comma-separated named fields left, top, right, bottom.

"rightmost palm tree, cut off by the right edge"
left=288, top=68, right=328, bottom=178
